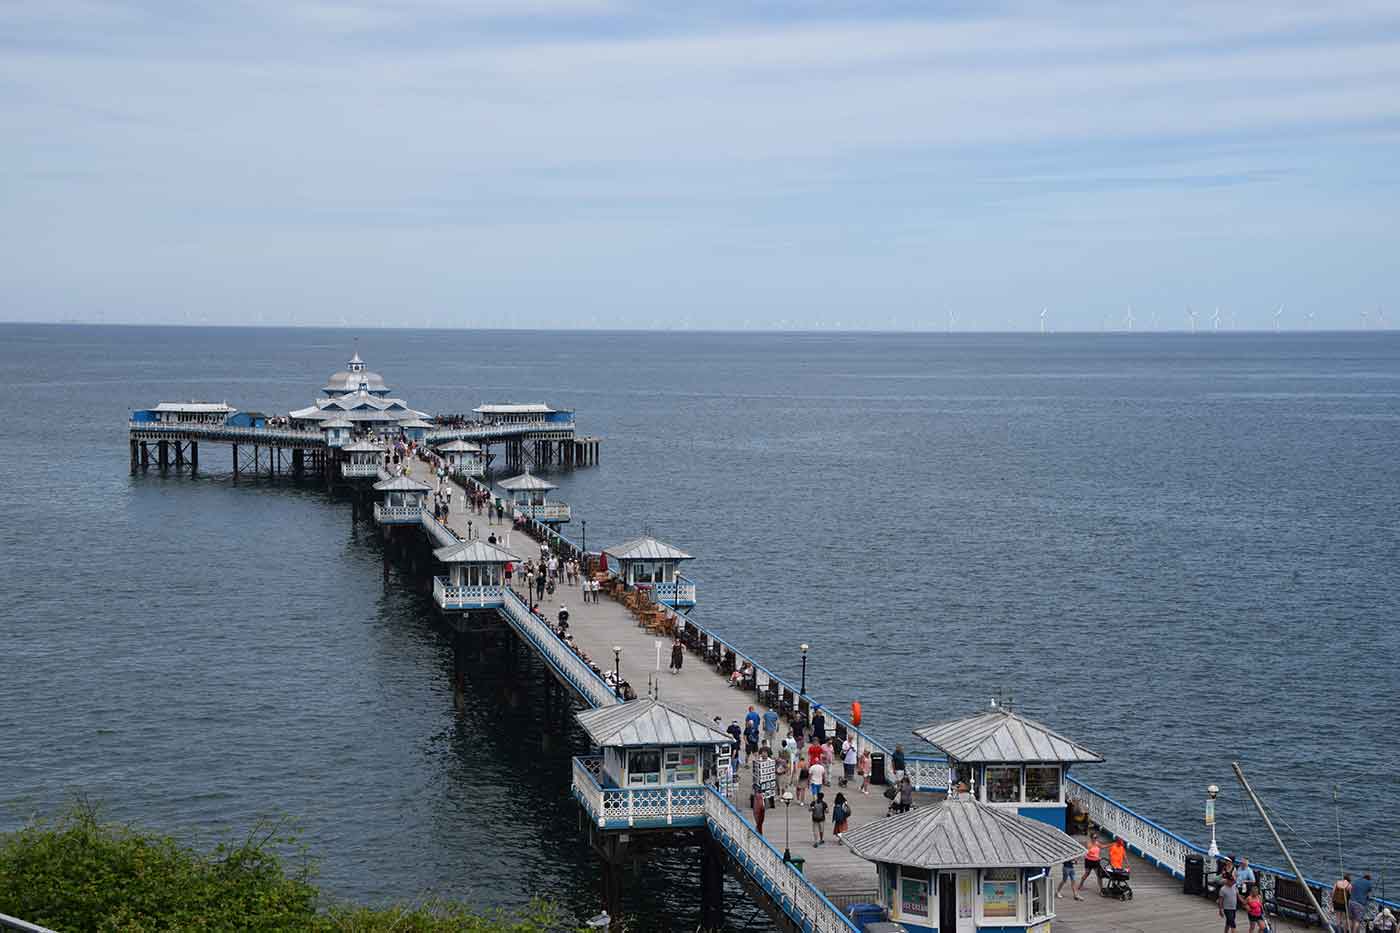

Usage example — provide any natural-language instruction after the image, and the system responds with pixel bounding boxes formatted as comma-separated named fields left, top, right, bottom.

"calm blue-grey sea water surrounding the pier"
left=0, top=325, right=1400, bottom=926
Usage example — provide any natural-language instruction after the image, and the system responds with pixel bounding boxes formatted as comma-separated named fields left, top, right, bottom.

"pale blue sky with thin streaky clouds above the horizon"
left=0, top=0, right=1400, bottom=331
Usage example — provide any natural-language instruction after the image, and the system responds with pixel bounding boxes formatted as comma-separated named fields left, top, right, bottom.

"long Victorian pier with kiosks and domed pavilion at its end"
left=129, top=356, right=1400, bottom=933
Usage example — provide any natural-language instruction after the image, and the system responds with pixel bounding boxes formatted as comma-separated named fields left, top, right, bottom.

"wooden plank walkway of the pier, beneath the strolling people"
left=428, top=486, right=1316, bottom=933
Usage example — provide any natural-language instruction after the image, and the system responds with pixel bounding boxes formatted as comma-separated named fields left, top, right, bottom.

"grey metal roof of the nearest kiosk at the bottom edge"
left=841, top=796, right=1084, bottom=869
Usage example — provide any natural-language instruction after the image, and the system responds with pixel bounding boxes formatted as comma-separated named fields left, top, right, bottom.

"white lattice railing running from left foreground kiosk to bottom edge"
left=704, top=787, right=858, bottom=933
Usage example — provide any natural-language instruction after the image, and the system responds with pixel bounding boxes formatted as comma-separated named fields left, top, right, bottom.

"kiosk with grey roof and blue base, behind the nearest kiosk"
left=914, top=706, right=1103, bottom=831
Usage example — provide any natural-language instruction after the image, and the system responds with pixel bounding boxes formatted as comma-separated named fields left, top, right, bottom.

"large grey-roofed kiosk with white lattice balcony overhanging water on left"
left=573, top=698, right=734, bottom=829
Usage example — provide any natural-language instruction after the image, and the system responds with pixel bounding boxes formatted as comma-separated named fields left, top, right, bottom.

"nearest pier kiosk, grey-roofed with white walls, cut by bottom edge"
left=841, top=794, right=1084, bottom=933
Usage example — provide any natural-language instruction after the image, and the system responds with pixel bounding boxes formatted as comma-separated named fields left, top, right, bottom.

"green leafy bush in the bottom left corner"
left=0, top=801, right=568, bottom=933
